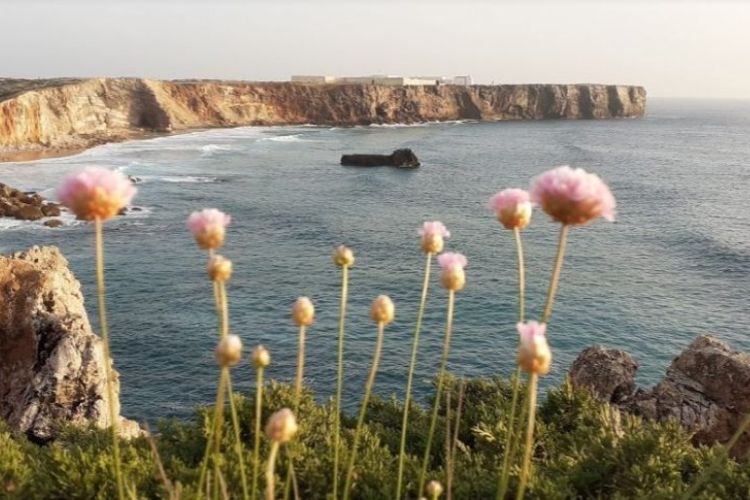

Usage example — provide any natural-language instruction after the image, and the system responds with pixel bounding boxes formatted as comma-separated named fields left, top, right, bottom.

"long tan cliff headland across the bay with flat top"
left=0, top=78, right=646, bottom=153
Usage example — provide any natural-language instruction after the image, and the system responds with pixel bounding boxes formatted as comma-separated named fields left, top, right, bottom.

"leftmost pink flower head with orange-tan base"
left=57, top=167, right=136, bottom=220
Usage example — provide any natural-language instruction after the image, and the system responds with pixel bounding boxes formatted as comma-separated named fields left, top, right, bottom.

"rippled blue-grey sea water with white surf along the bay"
left=0, top=99, right=750, bottom=419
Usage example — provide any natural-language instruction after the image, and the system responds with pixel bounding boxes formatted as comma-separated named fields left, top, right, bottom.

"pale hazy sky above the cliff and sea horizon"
left=0, top=0, right=750, bottom=98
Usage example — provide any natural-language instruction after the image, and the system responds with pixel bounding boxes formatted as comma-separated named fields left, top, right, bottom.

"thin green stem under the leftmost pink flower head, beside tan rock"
left=94, top=217, right=125, bottom=500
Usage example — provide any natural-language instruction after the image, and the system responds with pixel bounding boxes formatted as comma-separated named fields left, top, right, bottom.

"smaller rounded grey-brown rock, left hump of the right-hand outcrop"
left=570, top=346, right=638, bottom=403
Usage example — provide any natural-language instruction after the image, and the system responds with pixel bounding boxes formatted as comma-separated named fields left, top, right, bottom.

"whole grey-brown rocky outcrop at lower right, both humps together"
left=570, top=336, right=750, bottom=457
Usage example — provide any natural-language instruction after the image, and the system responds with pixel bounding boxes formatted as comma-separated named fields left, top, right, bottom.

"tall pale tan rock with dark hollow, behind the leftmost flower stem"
left=0, top=247, right=140, bottom=442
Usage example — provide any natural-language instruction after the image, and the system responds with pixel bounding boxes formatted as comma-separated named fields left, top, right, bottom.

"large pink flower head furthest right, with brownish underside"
left=531, top=165, right=615, bottom=224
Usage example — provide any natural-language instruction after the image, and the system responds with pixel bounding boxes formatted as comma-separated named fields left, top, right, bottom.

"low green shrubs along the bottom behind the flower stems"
left=0, top=378, right=750, bottom=499
